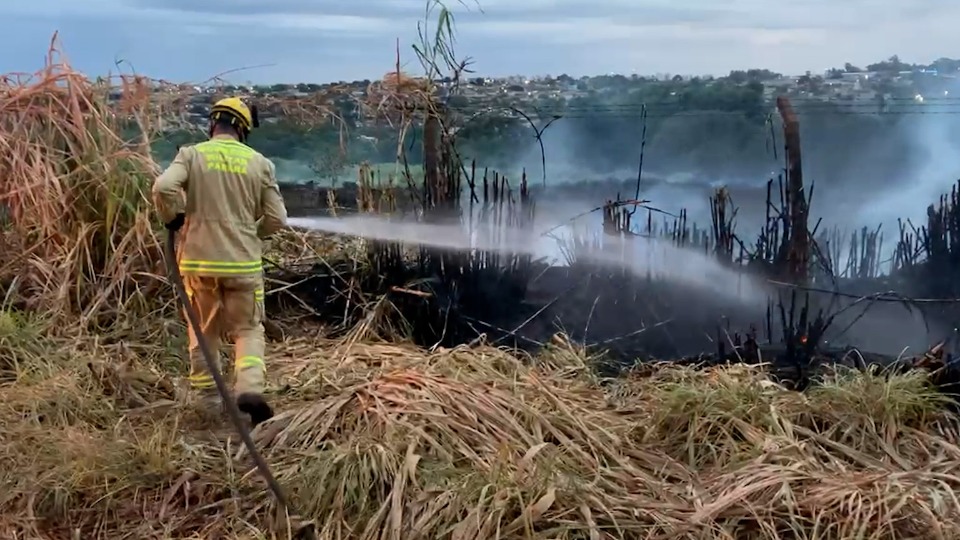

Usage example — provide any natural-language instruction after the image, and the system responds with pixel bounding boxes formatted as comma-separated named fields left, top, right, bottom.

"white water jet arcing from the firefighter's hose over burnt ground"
left=290, top=210, right=949, bottom=355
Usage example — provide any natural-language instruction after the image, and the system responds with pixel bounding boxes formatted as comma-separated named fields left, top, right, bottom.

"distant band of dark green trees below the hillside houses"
left=154, top=56, right=960, bottom=181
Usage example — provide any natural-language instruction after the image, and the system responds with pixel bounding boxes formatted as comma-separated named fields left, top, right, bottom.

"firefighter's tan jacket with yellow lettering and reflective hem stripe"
left=153, top=136, right=287, bottom=277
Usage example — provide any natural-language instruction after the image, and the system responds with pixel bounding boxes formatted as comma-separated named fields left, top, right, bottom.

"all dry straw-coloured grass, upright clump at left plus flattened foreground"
left=0, top=40, right=960, bottom=540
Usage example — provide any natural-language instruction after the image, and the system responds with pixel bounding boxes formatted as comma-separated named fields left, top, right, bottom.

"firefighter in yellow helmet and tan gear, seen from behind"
left=153, top=97, right=287, bottom=426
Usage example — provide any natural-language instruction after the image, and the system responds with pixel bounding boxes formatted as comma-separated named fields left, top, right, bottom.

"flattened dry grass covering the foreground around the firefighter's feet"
left=0, top=325, right=960, bottom=539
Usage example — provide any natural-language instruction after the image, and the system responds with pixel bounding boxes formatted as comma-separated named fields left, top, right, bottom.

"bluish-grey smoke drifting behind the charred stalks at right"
left=473, top=94, right=960, bottom=244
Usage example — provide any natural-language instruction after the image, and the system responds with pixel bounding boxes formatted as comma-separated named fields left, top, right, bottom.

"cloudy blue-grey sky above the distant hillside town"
left=0, top=0, right=960, bottom=82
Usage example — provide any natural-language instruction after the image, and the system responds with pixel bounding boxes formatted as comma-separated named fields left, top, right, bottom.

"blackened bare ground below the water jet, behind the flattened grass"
left=268, top=249, right=951, bottom=392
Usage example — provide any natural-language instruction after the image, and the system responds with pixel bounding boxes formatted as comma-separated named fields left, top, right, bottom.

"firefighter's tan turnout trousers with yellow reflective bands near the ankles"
left=183, top=274, right=266, bottom=395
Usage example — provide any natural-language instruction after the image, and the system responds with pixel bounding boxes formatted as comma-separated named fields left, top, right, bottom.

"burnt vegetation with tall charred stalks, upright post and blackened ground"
left=273, top=65, right=960, bottom=394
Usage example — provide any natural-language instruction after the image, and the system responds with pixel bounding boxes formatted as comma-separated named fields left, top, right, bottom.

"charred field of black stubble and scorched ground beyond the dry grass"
left=274, top=148, right=960, bottom=390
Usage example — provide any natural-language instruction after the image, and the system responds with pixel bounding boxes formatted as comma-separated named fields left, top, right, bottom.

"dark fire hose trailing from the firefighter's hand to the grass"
left=164, top=230, right=312, bottom=537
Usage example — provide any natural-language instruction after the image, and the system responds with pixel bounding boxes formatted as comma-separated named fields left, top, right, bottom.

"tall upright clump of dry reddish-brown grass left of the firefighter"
left=0, top=38, right=161, bottom=323
